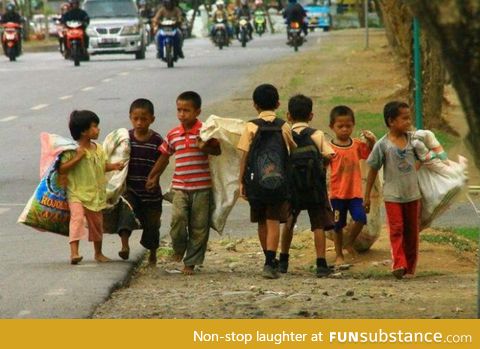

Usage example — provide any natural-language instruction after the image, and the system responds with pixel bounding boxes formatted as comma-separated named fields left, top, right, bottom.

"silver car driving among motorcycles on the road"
left=83, top=0, right=147, bottom=59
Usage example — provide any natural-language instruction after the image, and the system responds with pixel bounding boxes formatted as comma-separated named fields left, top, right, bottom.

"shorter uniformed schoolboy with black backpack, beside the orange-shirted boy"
left=279, top=95, right=335, bottom=277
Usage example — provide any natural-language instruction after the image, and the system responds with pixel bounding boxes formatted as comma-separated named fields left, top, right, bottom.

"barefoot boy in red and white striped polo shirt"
left=146, top=91, right=220, bottom=275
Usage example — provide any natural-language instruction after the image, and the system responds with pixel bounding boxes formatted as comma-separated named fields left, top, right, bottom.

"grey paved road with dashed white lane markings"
left=0, top=33, right=330, bottom=318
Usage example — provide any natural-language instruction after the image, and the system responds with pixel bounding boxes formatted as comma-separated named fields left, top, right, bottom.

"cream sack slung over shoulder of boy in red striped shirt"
left=200, top=115, right=245, bottom=234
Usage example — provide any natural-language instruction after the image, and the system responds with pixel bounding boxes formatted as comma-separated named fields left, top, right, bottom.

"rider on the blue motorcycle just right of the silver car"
left=152, top=0, right=185, bottom=60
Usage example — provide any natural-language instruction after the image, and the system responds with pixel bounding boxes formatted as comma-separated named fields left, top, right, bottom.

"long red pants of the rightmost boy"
left=385, top=200, right=420, bottom=274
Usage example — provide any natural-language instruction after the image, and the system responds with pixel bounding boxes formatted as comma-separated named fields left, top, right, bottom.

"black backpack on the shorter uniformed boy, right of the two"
left=290, top=127, right=328, bottom=210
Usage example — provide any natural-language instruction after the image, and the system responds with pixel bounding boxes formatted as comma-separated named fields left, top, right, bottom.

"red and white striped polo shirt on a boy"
left=158, top=119, right=212, bottom=190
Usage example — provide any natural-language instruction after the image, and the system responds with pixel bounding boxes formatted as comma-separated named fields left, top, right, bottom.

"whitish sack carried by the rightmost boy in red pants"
left=412, top=130, right=467, bottom=230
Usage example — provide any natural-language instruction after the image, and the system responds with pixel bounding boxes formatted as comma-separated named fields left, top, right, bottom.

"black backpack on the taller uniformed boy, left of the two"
left=243, top=118, right=290, bottom=204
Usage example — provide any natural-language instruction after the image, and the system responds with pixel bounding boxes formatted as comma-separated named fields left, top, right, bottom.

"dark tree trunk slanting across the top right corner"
left=408, top=0, right=480, bottom=167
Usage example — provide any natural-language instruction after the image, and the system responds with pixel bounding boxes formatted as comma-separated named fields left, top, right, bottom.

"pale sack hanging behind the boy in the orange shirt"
left=327, top=160, right=383, bottom=252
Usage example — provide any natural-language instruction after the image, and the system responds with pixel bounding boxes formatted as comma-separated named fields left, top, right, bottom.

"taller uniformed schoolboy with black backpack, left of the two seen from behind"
left=237, top=84, right=296, bottom=279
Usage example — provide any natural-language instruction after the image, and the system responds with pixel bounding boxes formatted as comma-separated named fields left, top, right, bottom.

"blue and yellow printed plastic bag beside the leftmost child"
left=18, top=154, right=70, bottom=236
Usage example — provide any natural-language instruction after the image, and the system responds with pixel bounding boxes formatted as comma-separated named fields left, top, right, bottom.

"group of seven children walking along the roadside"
left=59, top=84, right=420, bottom=279
